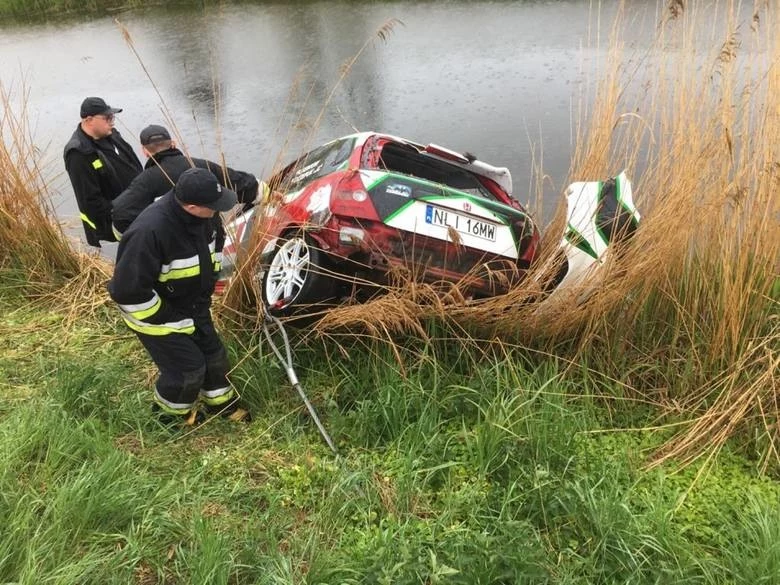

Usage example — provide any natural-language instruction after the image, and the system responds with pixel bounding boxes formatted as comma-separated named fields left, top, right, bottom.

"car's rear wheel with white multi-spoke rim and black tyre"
left=261, top=231, right=333, bottom=315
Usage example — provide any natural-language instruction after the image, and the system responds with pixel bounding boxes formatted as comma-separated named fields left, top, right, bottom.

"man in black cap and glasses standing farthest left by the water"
left=63, top=97, right=142, bottom=248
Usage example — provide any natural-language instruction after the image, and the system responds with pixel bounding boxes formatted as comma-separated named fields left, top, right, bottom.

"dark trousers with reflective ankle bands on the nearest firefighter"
left=135, top=308, right=235, bottom=415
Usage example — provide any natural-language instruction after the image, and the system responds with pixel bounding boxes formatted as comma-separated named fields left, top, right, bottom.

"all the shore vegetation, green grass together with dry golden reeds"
left=0, top=4, right=780, bottom=585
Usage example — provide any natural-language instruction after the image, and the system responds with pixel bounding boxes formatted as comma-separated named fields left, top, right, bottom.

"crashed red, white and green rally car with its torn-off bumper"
left=220, top=132, right=639, bottom=314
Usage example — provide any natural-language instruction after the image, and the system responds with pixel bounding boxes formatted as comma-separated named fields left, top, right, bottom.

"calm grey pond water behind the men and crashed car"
left=0, top=0, right=657, bottom=246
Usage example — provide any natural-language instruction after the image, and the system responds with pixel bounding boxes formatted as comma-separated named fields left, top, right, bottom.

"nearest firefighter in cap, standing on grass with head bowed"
left=108, top=168, right=249, bottom=424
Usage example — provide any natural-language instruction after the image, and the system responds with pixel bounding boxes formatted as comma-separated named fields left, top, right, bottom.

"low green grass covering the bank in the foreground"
left=0, top=282, right=780, bottom=584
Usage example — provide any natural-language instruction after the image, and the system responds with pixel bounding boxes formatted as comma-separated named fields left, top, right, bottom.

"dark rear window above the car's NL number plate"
left=379, top=142, right=497, bottom=201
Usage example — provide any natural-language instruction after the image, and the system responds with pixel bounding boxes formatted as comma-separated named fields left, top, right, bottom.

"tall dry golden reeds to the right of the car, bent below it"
left=221, top=2, right=780, bottom=466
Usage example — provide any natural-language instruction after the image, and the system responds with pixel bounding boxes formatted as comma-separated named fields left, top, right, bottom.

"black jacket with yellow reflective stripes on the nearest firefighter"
left=108, top=191, right=225, bottom=335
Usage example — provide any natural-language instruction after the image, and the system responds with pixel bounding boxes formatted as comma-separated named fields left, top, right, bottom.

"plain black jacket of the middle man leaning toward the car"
left=111, top=148, right=257, bottom=237
